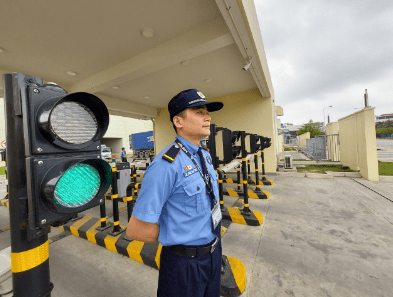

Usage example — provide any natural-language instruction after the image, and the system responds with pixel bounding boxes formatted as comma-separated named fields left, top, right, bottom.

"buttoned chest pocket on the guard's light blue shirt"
left=183, top=179, right=206, bottom=214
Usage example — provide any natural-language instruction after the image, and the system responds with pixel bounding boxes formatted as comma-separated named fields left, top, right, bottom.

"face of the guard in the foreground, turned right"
left=175, top=105, right=211, bottom=139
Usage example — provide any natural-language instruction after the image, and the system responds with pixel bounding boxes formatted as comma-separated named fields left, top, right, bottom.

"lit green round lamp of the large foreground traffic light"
left=54, top=163, right=101, bottom=208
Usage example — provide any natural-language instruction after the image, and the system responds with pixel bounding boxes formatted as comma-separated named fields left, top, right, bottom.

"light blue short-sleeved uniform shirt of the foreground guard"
left=132, top=136, right=219, bottom=246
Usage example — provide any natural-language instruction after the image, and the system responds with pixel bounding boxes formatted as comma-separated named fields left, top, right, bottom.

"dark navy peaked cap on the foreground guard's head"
left=168, top=89, right=224, bottom=122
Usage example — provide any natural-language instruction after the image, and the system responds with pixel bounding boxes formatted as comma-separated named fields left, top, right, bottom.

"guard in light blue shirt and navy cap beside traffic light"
left=126, top=89, right=224, bottom=297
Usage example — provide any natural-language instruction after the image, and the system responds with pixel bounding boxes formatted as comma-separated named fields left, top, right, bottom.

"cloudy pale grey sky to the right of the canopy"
left=254, top=0, right=393, bottom=125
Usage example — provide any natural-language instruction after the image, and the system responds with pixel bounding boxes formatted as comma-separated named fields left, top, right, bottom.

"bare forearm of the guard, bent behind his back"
left=126, top=216, right=160, bottom=242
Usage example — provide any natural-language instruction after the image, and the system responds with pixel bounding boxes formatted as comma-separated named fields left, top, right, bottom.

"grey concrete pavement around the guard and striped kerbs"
left=0, top=176, right=393, bottom=297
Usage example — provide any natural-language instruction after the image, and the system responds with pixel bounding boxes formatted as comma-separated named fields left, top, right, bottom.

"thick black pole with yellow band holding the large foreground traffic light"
left=3, top=74, right=53, bottom=297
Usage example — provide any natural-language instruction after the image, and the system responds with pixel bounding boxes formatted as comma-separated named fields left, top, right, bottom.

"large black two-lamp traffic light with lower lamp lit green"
left=8, top=73, right=112, bottom=230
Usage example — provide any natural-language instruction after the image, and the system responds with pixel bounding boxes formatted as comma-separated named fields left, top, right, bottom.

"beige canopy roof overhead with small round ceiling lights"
left=0, top=0, right=272, bottom=119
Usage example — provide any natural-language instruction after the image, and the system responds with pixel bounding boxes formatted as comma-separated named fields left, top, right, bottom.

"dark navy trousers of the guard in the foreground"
left=157, top=240, right=222, bottom=297
